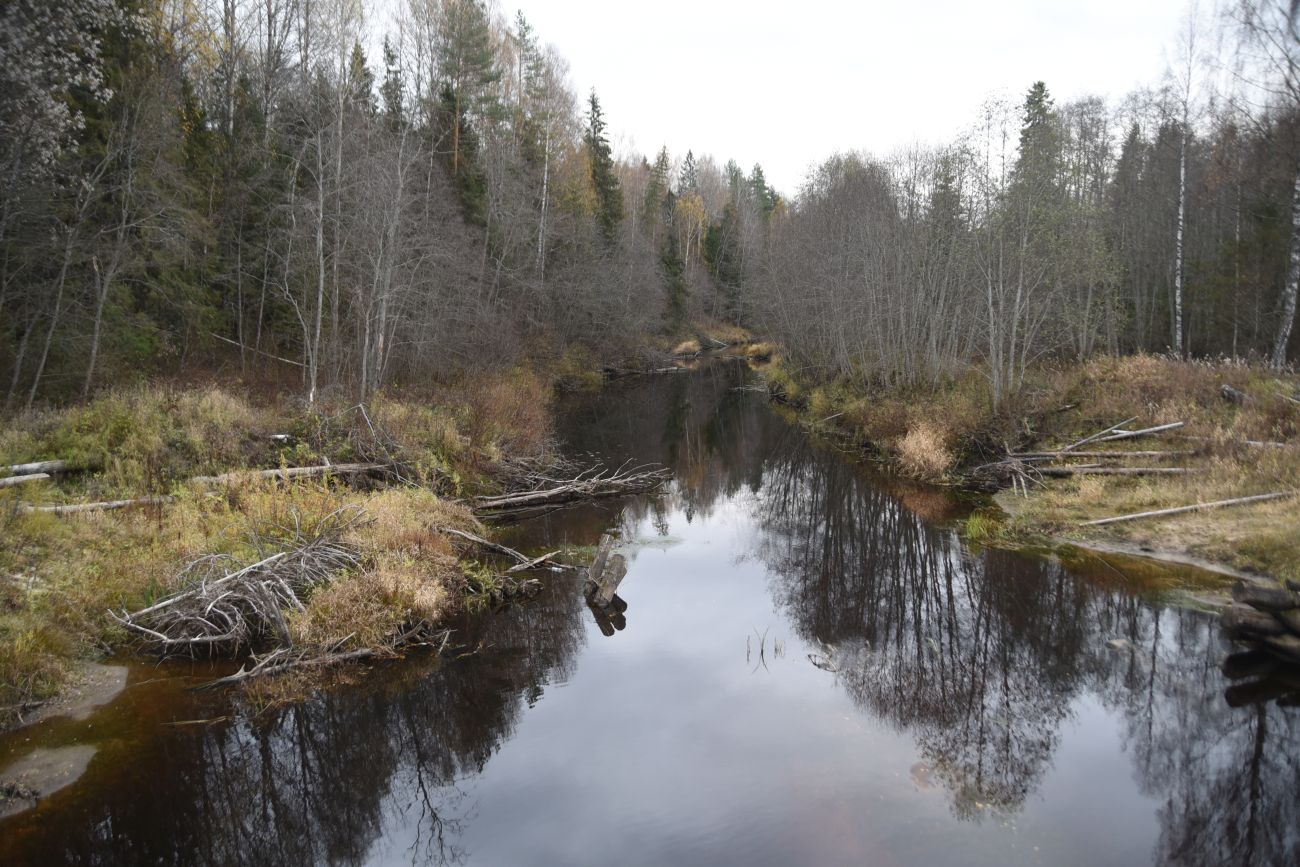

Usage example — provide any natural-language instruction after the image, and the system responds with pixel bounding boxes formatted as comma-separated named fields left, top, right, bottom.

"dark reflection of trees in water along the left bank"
left=18, top=571, right=585, bottom=864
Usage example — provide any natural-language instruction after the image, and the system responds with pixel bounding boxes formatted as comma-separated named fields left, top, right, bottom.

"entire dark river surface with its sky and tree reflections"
left=0, top=364, right=1300, bottom=867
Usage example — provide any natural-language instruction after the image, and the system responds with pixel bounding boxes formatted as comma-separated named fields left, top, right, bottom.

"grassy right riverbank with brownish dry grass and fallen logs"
left=764, top=355, right=1300, bottom=577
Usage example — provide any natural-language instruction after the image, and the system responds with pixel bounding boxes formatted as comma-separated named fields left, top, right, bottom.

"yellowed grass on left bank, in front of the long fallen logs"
left=0, top=482, right=488, bottom=706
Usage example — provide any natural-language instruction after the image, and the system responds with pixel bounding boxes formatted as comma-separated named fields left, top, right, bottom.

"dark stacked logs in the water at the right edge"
left=1219, top=578, right=1300, bottom=705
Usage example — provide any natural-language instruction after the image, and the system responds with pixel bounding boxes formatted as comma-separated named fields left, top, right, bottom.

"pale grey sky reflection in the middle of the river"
left=436, top=498, right=1156, bottom=864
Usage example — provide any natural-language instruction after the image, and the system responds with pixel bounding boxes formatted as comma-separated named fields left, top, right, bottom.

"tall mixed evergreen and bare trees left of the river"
left=0, top=0, right=776, bottom=407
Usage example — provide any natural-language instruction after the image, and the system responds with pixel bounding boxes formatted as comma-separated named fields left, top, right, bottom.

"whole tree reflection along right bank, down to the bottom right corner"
left=754, top=423, right=1300, bottom=864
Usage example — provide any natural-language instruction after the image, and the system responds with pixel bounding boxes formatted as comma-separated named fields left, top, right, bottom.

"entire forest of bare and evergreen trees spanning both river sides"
left=0, top=0, right=1300, bottom=411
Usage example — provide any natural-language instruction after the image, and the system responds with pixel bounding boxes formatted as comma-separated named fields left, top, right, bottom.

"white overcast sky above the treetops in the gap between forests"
left=377, top=0, right=1213, bottom=192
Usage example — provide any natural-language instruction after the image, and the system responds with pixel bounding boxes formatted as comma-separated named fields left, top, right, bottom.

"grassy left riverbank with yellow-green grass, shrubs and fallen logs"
left=0, top=370, right=556, bottom=723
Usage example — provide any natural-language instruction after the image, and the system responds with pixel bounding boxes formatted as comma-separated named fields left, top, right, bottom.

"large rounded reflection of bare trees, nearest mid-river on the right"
left=755, top=443, right=1083, bottom=814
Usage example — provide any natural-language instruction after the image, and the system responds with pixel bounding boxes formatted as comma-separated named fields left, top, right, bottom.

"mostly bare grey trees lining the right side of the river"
left=754, top=0, right=1300, bottom=400
